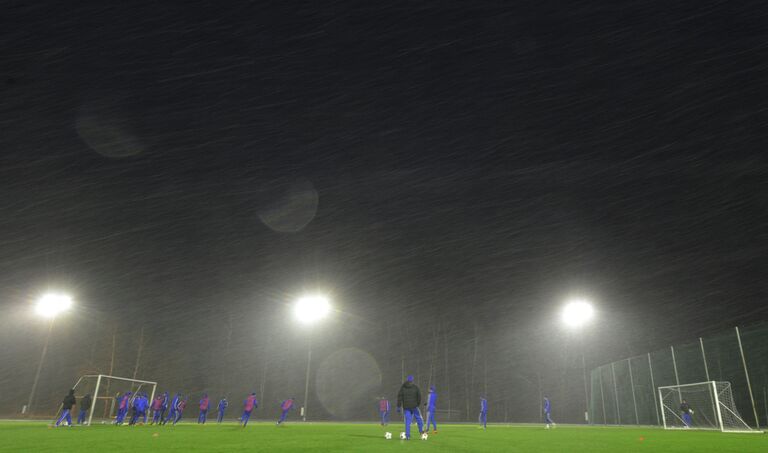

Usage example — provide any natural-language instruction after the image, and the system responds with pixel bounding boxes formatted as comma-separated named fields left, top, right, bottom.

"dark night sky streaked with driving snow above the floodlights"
left=0, top=1, right=768, bottom=422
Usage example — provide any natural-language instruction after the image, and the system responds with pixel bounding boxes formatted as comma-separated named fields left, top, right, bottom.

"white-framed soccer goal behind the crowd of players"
left=72, top=374, right=157, bottom=425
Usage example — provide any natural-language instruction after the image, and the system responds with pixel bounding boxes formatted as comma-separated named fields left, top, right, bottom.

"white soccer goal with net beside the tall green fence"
left=659, top=381, right=762, bottom=433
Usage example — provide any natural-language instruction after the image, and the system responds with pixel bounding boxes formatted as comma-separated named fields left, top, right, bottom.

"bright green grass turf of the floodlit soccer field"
left=0, top=422, right=768, bottom=453
